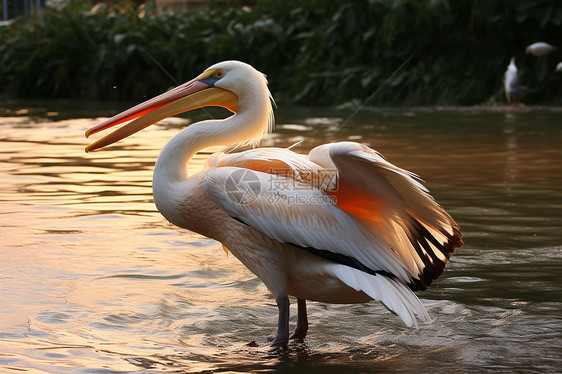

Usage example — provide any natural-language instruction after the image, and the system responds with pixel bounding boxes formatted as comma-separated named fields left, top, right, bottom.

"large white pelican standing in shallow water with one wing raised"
left=86, top=61, right=462, bottom=347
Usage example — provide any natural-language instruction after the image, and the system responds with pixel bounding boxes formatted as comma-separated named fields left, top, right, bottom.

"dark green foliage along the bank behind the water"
left=0, top=0, right=562, bottom=105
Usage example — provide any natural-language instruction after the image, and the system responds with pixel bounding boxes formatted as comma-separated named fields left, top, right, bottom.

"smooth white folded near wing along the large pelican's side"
left=204, top=167, right=409, bottom=282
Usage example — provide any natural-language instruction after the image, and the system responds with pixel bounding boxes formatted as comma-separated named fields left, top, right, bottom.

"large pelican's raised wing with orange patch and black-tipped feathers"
left=309, top=142, right=462, bottom=290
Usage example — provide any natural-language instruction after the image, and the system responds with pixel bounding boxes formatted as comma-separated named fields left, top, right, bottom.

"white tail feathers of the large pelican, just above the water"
left=333, top=265, right=429, bottom=328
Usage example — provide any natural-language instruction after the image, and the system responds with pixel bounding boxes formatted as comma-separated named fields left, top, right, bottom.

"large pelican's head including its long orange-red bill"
left=86, top=61, right=273, bottom=152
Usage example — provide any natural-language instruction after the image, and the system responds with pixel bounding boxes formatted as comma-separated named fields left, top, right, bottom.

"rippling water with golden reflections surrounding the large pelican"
left=0, top=103, right=562, bottom=373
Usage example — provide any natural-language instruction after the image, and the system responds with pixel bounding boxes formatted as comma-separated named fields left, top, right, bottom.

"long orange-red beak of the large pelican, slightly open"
left=86, top=71, right=238, bottom=152
